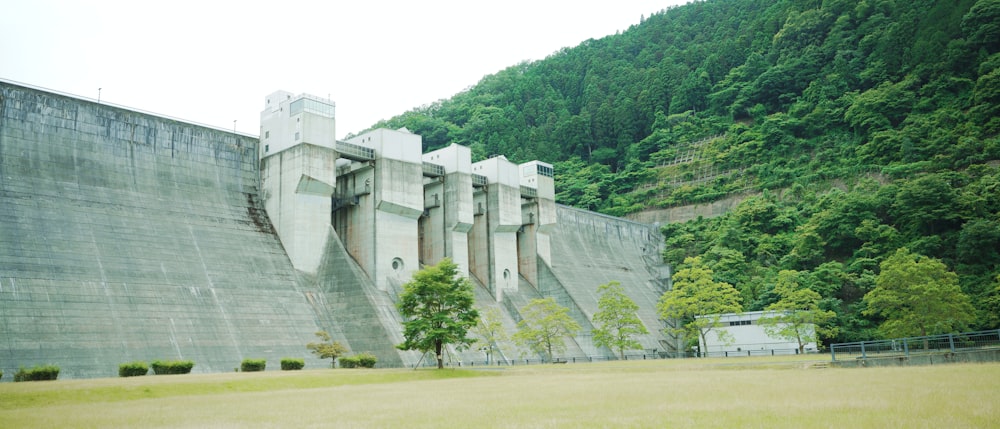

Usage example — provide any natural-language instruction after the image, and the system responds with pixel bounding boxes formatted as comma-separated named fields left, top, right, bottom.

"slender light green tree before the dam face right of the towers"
left=593, top=281, right=649, bottom=359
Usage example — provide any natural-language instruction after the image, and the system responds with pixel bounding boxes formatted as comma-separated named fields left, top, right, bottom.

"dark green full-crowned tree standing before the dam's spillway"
left=396, top=258, right=479, bottom=369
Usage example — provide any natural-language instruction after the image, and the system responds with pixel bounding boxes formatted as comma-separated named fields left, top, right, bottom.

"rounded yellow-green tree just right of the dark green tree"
left=514, top=297, right=580, bottom=362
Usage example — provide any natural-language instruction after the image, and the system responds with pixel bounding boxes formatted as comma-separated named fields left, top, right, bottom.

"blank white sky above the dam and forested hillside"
left=0, top=0, right=687, bottom=138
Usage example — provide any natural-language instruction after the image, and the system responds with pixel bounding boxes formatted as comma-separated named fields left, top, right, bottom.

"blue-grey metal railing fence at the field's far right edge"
left=830, top=329, right=1000, bottom=362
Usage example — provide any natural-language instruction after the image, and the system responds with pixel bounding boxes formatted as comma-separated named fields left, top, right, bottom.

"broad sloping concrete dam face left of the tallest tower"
left=0, top=83, right=328, bottom=378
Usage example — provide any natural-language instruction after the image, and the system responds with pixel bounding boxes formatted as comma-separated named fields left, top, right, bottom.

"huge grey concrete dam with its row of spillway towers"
left=0, top=81, right=677, bottom=381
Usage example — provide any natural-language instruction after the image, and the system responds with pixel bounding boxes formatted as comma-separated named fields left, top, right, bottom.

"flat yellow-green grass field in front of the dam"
left=0, top=358, right=1000, bottom=428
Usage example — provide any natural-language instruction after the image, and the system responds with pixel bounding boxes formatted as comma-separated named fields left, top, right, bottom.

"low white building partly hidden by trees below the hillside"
left=698, top=311, right=816, bottom=357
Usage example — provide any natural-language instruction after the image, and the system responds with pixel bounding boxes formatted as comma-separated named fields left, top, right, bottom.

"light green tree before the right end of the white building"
left=760, top=270, right=837, bottom=354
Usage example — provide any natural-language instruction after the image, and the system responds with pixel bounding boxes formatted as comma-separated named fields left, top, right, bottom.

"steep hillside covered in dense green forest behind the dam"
left=368, top=0, right=1000, bottom=341
